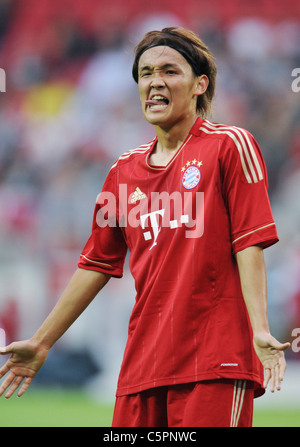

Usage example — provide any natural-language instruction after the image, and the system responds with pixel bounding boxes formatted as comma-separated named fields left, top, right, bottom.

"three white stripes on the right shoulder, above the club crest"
left=200, top=120, right=263, bottom=183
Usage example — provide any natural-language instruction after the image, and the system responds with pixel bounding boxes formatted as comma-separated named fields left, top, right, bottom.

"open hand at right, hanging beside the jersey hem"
left=253, top=332, right=290, bottom=393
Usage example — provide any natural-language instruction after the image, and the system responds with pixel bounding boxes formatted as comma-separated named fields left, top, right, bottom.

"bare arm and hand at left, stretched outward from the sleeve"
left=0, top=269, right=110, bottom=398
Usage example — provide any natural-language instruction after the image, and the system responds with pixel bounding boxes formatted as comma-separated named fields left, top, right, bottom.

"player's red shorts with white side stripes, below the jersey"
left=112, top=380, right=254, bottom=427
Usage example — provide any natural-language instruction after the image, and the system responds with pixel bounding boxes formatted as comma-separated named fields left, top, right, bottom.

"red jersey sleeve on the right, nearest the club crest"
left=221, top=128, right=279, bottom=253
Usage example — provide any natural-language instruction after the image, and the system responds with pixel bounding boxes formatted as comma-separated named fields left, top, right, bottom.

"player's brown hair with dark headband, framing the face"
left=132, top=26, right=217, bottom=117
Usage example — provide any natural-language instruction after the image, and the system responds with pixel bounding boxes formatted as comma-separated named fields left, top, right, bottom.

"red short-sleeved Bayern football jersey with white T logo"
left=78, top=118, right=278, bottom=395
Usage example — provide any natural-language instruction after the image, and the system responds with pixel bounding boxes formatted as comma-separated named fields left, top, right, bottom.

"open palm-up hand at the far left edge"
left=0, top=339, right=48, bottom=399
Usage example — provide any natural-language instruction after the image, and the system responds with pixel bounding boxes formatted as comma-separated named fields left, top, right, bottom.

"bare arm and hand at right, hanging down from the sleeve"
left=236, top=246, right=290, bottom=392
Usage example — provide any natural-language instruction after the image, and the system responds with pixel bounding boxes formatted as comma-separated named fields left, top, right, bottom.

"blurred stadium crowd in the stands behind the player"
left=0, top=0, right=300, bottom=398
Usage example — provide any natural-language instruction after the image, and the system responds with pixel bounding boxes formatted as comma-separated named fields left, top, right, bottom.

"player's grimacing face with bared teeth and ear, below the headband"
left=138, top=46, right=207, bottom=129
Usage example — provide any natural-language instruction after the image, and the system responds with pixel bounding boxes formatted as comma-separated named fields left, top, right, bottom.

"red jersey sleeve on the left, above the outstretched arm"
left=78, top=169, right=127, bottom=278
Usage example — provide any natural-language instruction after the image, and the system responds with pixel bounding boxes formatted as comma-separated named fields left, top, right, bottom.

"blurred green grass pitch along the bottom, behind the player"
left=0, top=389, right=300, bottom=427
